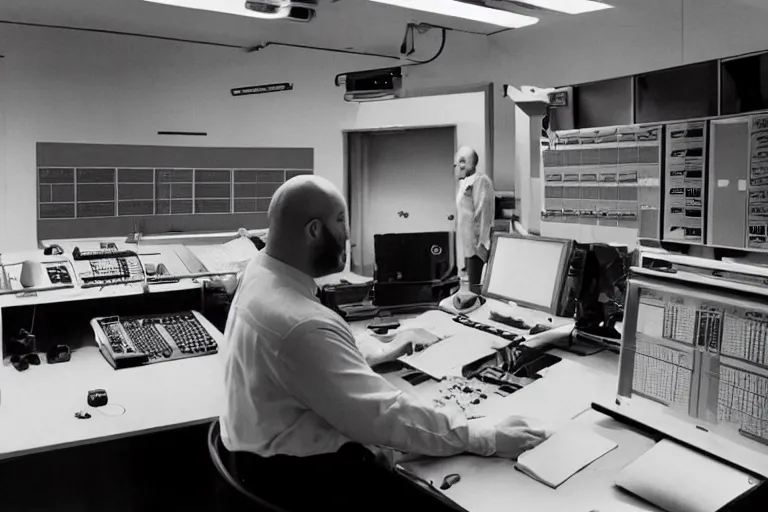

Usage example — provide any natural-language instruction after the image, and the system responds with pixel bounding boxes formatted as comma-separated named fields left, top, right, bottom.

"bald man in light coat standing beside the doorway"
left=454, top=146, right=495, bottom=294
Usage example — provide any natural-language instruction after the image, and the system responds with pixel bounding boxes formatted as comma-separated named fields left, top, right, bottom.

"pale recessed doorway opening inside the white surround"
left=347, top=126, right=456, bottom=277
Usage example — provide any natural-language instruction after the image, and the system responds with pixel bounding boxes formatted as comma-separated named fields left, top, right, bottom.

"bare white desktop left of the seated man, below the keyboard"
left=0, top=347, right=224, bottom=460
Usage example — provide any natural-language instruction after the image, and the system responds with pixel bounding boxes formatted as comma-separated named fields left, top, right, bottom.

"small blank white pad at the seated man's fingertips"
left=515, top=425, right=618, bottom=489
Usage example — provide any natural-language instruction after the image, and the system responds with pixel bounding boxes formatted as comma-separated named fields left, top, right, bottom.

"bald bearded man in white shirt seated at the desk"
left=221, top=176, right=544, bottom=511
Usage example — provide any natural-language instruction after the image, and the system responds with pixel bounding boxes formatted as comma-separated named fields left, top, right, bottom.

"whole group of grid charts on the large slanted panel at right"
left=632, top=289, right=768, bottom=443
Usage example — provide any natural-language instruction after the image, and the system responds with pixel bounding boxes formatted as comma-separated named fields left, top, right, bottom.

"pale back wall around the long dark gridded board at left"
left=0, top=26, right=390, bottom=252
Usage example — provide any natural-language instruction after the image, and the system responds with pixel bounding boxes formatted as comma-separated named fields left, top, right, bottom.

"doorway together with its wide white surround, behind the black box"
left=343, top=92, right=493, bottom=276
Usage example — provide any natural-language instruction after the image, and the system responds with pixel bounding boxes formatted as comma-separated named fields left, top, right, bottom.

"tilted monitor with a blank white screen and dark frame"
left=483, top=233, right=573, bottom=315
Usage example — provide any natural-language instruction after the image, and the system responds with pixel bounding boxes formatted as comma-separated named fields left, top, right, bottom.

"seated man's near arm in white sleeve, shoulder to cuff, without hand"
left=279, top=325, right=496, bottom=456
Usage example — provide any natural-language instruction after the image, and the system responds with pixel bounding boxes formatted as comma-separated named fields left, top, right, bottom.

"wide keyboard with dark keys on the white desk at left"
left=91, top=311, right=218, bottom=369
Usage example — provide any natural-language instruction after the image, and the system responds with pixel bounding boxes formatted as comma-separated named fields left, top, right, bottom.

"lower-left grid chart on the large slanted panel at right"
left=632, top=341, right=693, bottom=408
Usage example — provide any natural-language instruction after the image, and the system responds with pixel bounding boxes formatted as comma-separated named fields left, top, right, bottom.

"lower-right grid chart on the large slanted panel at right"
left=717, top=365, right=768, bottom=442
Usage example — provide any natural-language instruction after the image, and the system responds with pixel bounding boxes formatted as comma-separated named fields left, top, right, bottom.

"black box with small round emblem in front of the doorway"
left=373, top=231, right=458, bottom=283
